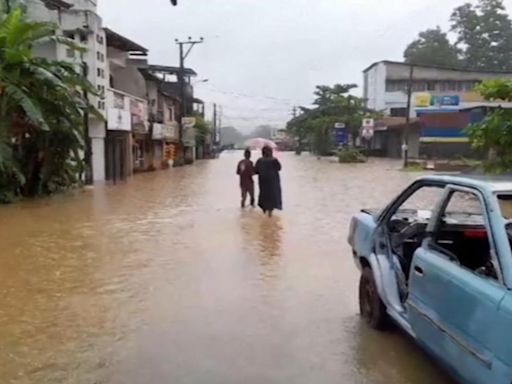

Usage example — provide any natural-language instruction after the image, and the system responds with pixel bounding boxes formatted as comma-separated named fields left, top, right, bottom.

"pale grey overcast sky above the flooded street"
left=99, top=0, right=512, bottom=131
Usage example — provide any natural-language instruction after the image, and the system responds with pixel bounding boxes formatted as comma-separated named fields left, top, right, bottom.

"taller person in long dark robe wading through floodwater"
left=254, top=147, right=283, bottom=216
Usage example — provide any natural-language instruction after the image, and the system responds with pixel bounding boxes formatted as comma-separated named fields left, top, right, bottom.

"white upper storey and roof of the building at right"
left=363, top=61, right=512, bottom=117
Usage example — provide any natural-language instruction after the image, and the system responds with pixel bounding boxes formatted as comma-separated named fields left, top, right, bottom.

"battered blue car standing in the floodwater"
left=348, top=176, right=512, bottom=384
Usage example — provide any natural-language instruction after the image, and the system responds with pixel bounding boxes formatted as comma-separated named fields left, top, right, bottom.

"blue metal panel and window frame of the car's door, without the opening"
left=406, top=186, right=510, bottom=384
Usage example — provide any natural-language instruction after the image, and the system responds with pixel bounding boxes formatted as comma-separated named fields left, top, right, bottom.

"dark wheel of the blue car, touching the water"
left=359, top=267, right=388, bottom=329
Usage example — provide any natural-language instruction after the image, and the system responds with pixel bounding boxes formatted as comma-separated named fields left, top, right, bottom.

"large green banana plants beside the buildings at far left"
left=0, top=8, right=99, bottom=200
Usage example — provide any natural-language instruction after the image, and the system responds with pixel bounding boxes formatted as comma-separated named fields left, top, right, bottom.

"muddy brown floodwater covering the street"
left=0, top=153, right=456, bottom=384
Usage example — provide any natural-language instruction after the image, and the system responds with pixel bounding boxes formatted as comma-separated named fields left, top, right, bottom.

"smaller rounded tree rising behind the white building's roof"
left=404, top=26, right=460, bottom=67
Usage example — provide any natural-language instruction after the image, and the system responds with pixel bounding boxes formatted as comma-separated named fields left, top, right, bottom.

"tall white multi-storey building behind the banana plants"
left=26, top=0, right=109, bottom=181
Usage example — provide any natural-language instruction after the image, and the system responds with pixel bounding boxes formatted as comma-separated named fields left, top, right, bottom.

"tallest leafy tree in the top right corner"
left=451, top=0, right=512, bottom=70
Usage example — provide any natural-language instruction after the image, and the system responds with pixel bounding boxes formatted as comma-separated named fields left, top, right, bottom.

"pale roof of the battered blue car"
left=420, top=174, right=512, bottom=193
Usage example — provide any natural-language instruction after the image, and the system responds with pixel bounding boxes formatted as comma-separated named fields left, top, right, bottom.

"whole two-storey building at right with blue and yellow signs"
left=363, top=61, right=512, bottom=158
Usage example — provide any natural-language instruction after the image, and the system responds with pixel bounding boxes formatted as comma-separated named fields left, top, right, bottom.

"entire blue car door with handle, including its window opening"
left=406, top=186, right=511, bottom=384
